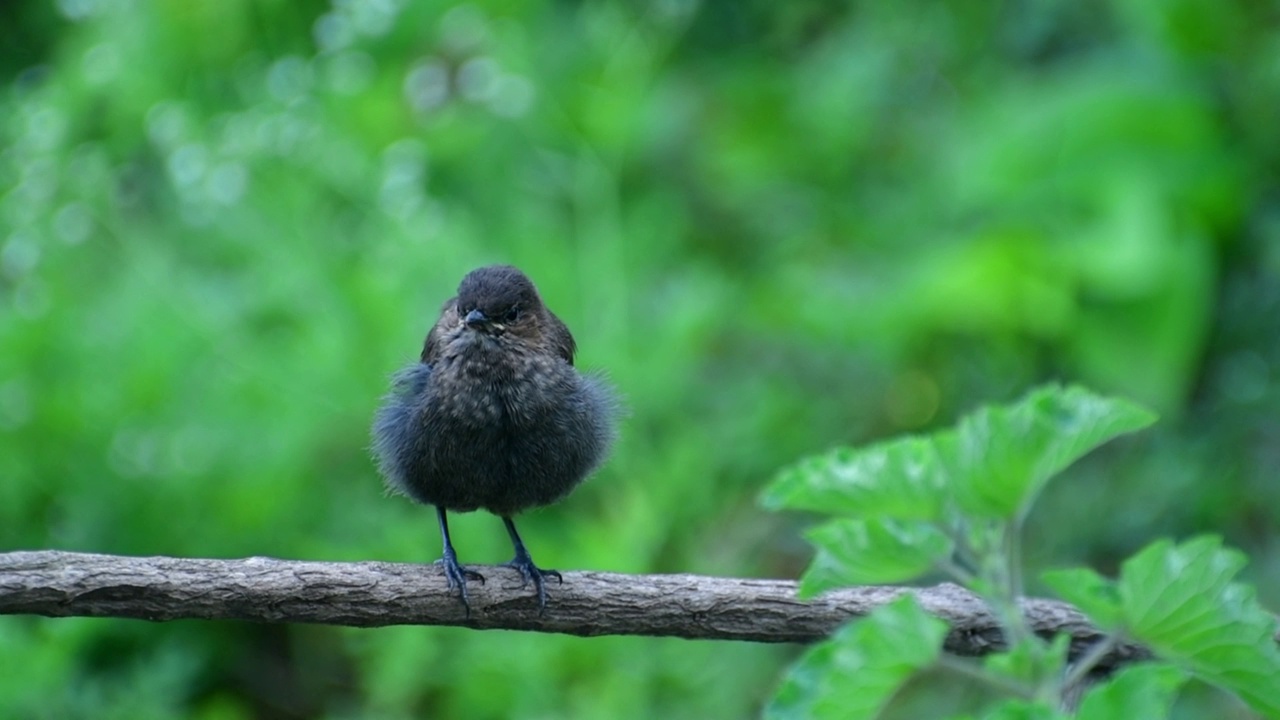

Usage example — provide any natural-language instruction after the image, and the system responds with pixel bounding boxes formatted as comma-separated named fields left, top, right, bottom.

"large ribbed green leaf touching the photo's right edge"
left=1117, top=537, right=1280, bottom=716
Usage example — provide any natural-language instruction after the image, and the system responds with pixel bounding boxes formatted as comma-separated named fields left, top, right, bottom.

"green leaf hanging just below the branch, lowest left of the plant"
left=764, top=596, right=947, bottom=720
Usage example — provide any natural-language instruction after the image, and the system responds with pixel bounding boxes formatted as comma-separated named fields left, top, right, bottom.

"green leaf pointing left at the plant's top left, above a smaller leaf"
left=762, top=437, right=946, bottom=520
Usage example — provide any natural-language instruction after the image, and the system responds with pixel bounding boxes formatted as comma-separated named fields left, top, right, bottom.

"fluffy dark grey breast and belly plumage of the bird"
left=374, top=350, right=614, bottom=515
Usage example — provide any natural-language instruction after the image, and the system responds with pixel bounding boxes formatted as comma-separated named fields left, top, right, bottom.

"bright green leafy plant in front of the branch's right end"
left=763, top=386, right=1280, bottom=719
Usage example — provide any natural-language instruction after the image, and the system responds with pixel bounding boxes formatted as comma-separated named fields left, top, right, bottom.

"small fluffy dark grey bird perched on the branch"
left=372, top=265, right=618, bottom=615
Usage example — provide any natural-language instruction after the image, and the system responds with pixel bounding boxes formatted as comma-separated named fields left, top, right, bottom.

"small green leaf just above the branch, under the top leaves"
left=800, top=519, right=954, bottom=597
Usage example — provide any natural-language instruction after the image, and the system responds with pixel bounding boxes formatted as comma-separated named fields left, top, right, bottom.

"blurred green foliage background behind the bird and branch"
left=0, top=0, right=1280, bottom=720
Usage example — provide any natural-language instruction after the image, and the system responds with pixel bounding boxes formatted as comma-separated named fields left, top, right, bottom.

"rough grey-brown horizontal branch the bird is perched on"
left=0, top=551, right=1147, bottom=667
